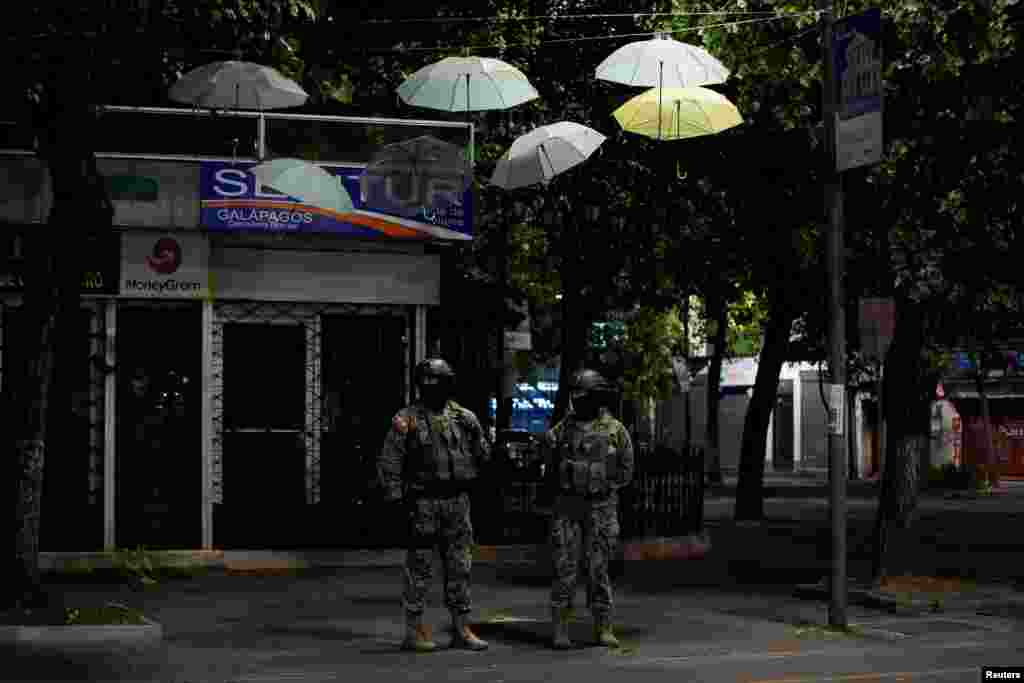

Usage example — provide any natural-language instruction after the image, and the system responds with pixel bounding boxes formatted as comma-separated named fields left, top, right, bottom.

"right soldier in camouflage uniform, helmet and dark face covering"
left=543, top=370, right=633, bottom=649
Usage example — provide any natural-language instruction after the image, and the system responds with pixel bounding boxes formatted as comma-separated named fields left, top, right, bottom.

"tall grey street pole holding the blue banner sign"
left=818, top=0, right=847, bottom=629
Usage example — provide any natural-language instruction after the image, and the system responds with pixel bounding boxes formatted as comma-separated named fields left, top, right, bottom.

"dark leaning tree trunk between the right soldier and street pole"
left=735, top=307, right=794, bottom=520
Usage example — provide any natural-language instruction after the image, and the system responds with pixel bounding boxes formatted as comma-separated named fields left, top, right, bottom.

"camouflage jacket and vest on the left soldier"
left=377, top=400, right=490, bottom=501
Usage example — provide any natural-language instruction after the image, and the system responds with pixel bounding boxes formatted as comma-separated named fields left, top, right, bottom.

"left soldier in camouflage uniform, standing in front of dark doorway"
left=377, top=358, right=490, bottom=652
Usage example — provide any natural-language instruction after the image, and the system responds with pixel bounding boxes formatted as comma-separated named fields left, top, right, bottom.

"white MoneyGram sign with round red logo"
left=121, top=232, right=210, bottom=299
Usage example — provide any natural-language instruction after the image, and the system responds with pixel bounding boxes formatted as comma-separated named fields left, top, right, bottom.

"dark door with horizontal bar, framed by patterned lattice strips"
left=213, top=323, right=306, bottom=548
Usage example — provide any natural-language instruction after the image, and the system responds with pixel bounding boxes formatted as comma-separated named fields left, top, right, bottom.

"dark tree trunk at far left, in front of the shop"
left=6, top=65, right=114, bottom=605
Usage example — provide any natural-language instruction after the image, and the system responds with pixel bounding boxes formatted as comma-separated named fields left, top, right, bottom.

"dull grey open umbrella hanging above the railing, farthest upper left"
left=168, top=60, right=309, bottom=111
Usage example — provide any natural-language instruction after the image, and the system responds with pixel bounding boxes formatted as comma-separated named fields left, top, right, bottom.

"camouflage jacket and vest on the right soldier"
left=542, top=412, right=634, bottom=500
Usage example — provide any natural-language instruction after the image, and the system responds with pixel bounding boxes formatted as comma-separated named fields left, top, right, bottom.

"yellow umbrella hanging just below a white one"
left=612, top=87, right=743, bottom=140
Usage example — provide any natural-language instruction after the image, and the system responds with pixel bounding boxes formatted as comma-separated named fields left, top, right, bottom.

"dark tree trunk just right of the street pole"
left=871, top=303, right=934, bottom=585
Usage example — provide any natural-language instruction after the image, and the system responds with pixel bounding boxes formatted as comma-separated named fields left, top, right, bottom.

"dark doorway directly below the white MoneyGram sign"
left=115, top=306, right=203, bottom=549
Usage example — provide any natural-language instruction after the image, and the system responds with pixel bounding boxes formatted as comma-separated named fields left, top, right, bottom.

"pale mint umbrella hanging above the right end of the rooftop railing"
left=398, top=56, right=540, bottom=113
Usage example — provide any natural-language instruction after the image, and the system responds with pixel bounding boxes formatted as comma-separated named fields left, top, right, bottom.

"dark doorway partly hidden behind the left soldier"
left=319, top=315, right=406, bottom=547
